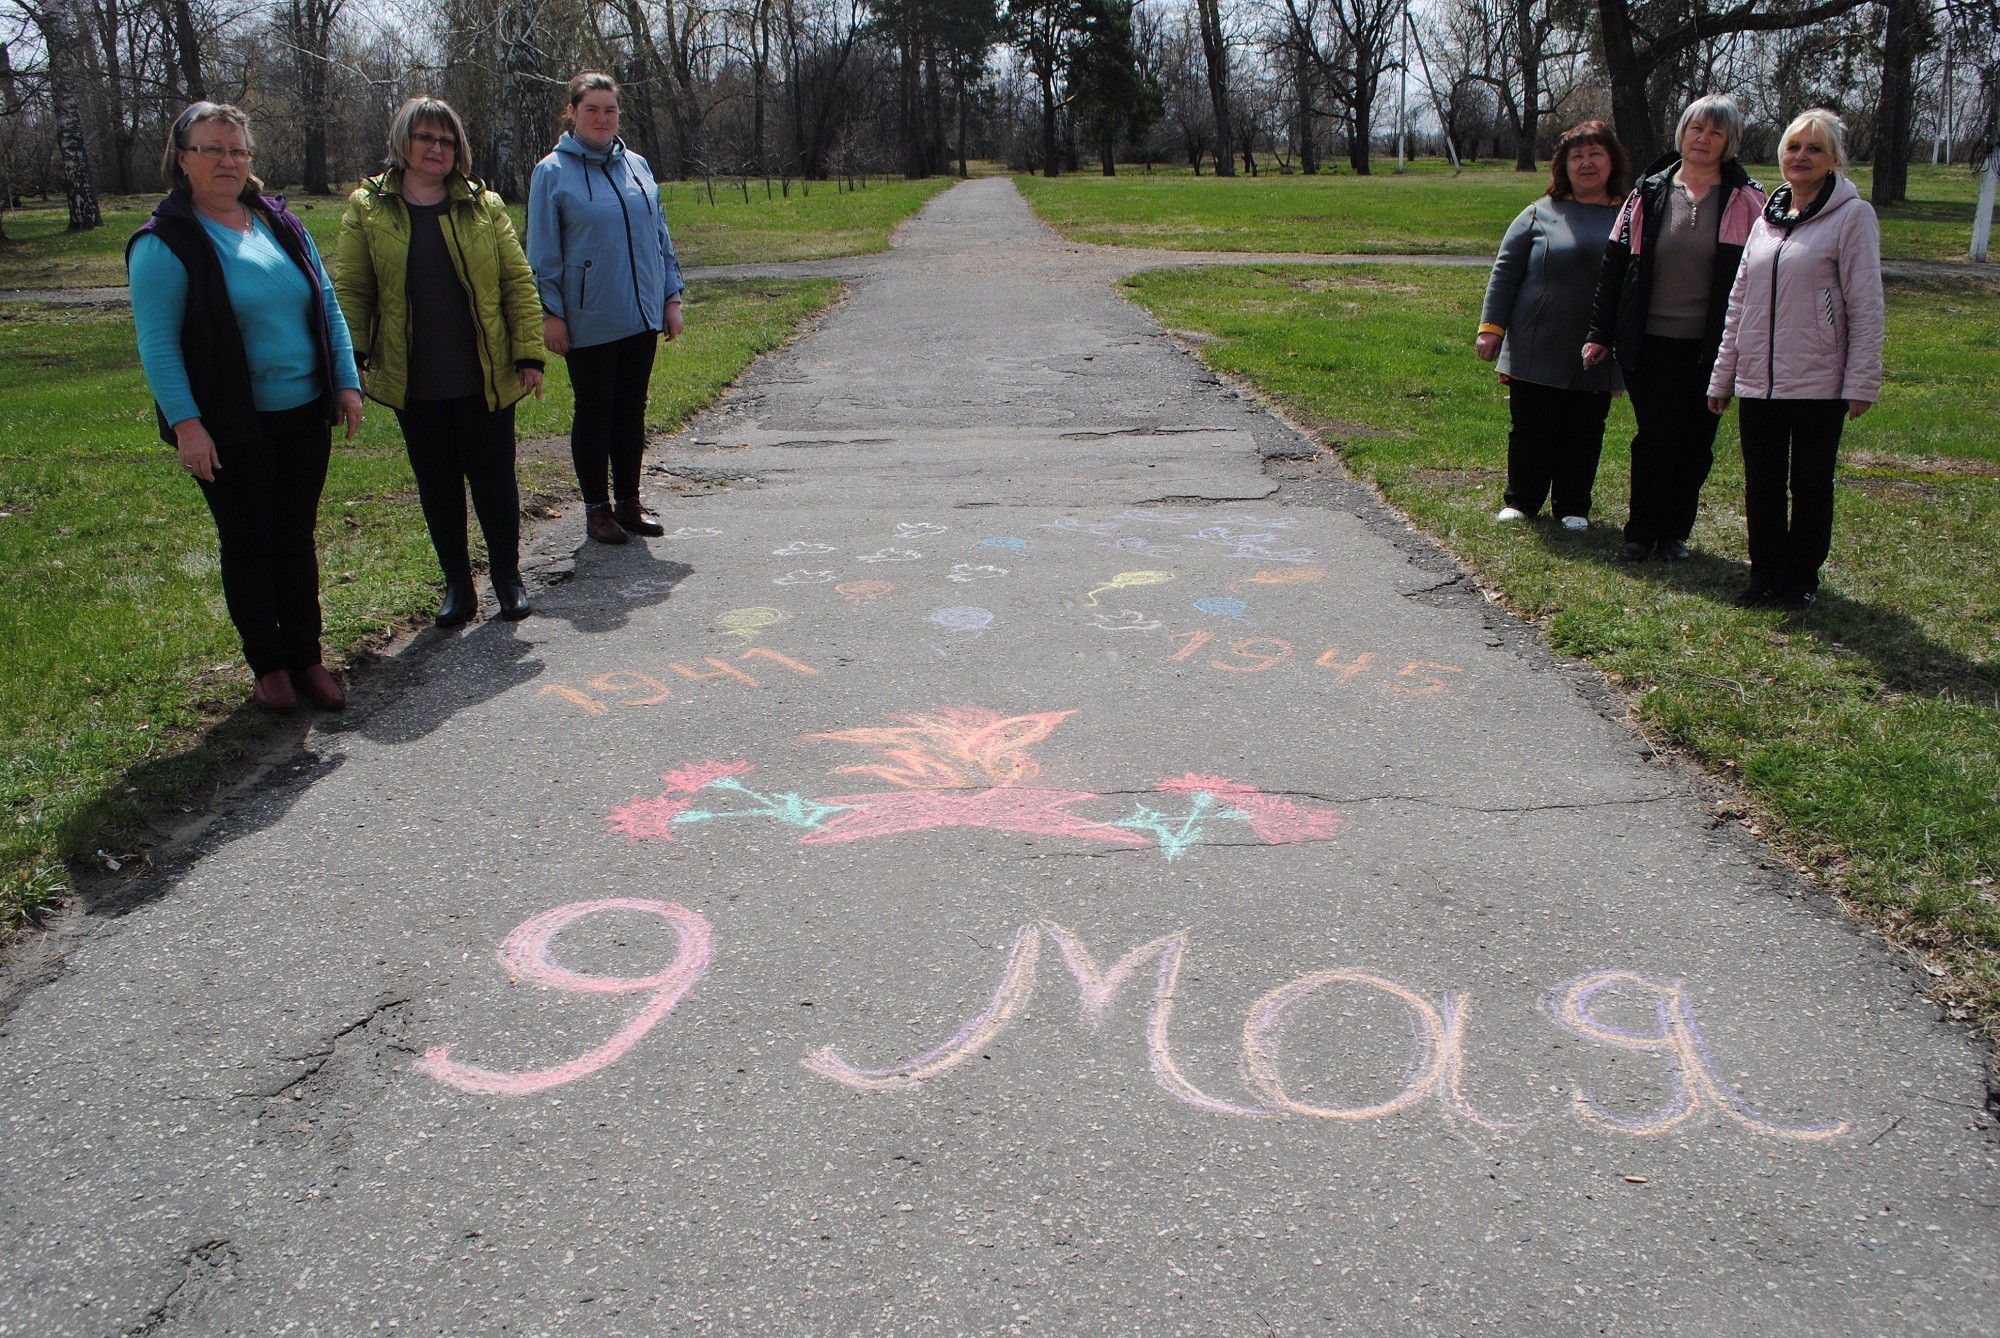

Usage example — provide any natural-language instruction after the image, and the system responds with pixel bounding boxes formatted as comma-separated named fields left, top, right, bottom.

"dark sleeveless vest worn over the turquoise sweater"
left=126, top=190, right=334, bottom=446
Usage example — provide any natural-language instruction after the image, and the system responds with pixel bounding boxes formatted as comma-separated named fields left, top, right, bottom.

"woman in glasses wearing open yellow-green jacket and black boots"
left=334, top=98, right=548, bottom=628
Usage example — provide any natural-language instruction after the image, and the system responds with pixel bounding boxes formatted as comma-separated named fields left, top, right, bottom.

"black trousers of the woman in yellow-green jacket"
left=396, top=394, right=520, bottom=584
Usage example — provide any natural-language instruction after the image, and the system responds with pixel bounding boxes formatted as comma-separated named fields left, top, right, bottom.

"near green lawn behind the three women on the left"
left=0, top=280, right=838, bottom=938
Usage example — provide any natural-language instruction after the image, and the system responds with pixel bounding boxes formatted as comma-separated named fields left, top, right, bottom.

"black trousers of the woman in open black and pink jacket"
left=1626, top=334, right=1722, bottom=544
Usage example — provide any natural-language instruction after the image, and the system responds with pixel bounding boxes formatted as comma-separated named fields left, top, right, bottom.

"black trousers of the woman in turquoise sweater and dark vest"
left=194, top=402, right=334, bottom=678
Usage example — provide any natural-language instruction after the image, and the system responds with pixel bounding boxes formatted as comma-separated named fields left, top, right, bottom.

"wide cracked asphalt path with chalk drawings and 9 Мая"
left=0, top=180, right=2000, bottom=1336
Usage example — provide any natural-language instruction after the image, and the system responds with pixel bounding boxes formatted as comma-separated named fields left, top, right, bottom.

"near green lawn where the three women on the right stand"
left=1130, top=266, right=2000, bottom=1034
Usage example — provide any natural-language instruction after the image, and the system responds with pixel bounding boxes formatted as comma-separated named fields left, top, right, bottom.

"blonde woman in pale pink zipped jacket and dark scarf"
left=1708, top=108, right=1882, bottom=608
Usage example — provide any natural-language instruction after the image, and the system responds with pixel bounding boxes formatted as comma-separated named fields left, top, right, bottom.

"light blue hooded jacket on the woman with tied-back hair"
left=528, top=134, right=682, bottom=348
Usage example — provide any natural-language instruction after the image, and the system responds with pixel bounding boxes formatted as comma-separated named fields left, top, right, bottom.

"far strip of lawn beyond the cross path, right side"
left=1014, top=158, right=1978, bottom=260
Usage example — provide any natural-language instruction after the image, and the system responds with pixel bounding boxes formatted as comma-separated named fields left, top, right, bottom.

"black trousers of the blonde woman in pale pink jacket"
left=1736, top=400, right=1848, bottom=594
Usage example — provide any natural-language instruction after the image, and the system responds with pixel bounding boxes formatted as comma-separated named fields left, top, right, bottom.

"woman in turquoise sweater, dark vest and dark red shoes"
left=126, top=102, right=362, bottom=710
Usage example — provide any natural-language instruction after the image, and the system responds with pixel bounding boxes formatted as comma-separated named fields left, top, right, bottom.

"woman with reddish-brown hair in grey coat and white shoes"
left=1476, top=120, right=1628, bottom=530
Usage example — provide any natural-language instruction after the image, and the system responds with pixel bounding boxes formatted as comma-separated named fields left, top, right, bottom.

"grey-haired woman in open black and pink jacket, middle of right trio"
left=1584, top=96, right=1764, bottom=562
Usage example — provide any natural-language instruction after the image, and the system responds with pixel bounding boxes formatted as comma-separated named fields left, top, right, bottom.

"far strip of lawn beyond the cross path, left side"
left=0, top=176, right=952, bottom=288
